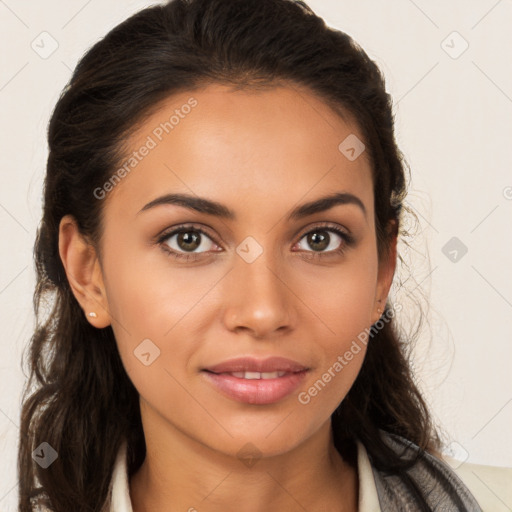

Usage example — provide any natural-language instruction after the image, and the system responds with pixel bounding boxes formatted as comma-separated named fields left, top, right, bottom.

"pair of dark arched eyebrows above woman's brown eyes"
left=139, top=192, right=366, bottom=221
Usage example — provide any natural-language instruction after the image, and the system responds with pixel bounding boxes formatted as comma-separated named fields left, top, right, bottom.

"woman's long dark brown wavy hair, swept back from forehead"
left=18, top=0, right=440, bottom=512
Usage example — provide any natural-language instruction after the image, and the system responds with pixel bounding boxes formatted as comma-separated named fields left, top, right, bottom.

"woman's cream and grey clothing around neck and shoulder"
left=103, top=433, right=512, bottom=512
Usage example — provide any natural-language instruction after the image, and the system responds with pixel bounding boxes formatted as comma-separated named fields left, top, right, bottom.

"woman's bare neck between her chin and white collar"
left=130, top=404, right=358, bottom=512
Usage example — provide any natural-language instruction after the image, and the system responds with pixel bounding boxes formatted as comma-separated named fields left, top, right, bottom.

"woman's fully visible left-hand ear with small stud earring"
left=59, top=215, right=111, bottom=328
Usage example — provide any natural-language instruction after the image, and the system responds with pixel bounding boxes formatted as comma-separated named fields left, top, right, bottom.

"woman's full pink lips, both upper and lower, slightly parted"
left=203, top=357, right=309, bottom=405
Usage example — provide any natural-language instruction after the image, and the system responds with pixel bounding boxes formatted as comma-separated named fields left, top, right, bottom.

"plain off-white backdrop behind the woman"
left=0, top=0, right=512, bottom=511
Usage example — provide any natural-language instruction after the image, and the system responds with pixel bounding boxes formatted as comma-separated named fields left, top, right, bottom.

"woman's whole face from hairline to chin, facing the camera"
left=74, top=85, right=393, bottom=455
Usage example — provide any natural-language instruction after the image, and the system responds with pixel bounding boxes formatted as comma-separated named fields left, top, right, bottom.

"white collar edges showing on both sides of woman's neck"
left=105, top=441, right=381, bottom=512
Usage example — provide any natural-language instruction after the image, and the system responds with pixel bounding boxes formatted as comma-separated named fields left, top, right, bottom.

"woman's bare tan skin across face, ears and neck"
left=60, top=85, right=396, bottom=512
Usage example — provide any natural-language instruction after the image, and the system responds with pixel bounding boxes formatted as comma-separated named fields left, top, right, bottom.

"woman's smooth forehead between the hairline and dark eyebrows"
left=107, top=84, right=373, bottom=220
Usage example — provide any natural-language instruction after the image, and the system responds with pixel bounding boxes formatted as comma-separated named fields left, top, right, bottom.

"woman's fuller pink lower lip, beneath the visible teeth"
left=203, top=370, right=307, bottom=405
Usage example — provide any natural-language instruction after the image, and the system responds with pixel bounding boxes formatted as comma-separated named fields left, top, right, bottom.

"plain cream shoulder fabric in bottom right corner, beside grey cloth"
left=442, top=455, right=512, bottom=512
